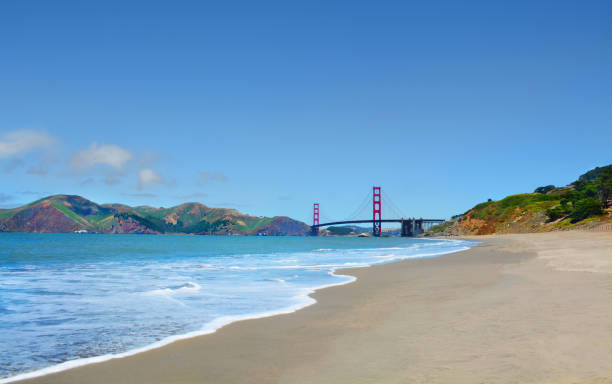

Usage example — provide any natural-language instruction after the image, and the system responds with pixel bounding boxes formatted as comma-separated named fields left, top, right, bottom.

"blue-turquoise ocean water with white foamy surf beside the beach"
left=0, top=233, right=471, bottom=383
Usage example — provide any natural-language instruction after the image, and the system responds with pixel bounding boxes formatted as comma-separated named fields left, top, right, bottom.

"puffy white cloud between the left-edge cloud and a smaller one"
left=70, top=142, right=133, bottom=171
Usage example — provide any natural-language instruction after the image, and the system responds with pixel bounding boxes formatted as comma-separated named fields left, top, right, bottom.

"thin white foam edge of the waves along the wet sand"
left=0, top=238, right=470, bottom=384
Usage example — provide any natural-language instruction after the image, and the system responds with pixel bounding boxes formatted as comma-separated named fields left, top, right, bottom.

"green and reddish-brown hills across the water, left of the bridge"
left=0, top=195, right=310, bottom=236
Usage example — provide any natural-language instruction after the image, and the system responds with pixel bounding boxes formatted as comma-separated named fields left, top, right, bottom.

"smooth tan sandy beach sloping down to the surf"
left=14, top=231, right=612, bottom=384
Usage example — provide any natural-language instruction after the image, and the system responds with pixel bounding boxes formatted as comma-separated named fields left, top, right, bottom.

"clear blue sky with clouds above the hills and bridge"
left=0, top=0, right=612, bottom=222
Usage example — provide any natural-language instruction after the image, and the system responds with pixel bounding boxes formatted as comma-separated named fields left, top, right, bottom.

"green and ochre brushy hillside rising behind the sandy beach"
left=429, top=165, right=612, bottom=235
